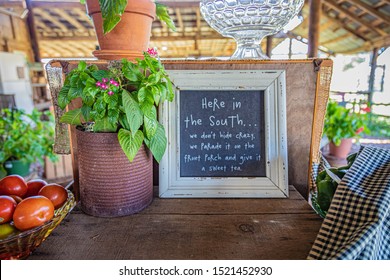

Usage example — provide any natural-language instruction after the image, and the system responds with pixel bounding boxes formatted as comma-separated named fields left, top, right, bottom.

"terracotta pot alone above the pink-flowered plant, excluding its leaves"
left=86, top=0, right=156, bottom=60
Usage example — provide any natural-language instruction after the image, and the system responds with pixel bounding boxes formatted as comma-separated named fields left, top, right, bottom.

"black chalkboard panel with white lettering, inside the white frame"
left=179, top=90, right=266, bottom=177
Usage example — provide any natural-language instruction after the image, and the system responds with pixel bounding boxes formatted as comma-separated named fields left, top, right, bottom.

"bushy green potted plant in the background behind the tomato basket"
left=0, top=109, right=57, bottom=177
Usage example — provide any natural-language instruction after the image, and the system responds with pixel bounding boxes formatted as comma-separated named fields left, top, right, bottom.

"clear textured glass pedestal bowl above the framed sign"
left=200, top=0, right=304, bottom=59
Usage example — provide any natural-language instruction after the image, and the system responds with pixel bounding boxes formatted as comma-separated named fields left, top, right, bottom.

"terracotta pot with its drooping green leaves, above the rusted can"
left=81, top=0, right=175, bottom=60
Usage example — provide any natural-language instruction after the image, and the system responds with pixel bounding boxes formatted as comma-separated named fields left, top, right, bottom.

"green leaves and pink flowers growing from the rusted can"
left=58, top=50, right=174, bottom=162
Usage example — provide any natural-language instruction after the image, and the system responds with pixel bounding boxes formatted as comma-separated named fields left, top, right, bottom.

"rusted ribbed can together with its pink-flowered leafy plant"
left=58, top=50, right=174, bottom=216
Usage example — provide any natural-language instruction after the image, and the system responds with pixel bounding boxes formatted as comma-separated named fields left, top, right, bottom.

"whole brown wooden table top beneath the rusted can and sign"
left=29, top=187, right=322, bottom=260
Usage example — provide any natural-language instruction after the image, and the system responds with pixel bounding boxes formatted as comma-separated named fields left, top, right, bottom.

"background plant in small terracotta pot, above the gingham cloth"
left=324, top=101, right=369, bottom=158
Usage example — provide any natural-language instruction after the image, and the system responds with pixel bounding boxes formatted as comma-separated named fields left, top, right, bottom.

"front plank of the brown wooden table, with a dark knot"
left=30, top=210, right=321, bottom=260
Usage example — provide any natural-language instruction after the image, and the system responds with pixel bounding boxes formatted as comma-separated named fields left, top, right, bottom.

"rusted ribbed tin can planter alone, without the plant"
left=76, top=129, right=153, bottom=217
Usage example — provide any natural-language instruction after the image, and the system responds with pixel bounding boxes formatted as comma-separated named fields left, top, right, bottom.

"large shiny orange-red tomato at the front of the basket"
left=13, top=195, right=54, bottom=231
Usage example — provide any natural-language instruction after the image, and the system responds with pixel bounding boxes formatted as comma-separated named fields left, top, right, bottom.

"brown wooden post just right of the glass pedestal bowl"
left=307, top=0, right=322, bottom=57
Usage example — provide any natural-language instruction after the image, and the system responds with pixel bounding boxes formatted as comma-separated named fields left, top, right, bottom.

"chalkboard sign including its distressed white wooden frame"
left=159, top=68, right=288, bottom=197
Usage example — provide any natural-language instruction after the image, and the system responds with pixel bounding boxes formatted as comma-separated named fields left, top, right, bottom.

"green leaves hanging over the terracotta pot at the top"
left=80, top=0, right=176, bottom=34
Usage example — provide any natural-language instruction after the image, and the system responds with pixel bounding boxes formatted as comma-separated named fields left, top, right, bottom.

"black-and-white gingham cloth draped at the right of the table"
left=308, top=147, right=390, bottom=260
